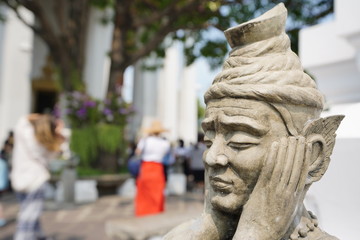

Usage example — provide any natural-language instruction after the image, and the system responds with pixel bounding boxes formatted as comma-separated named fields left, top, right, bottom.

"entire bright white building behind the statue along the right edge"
left=300, top=0, right=360, bottom=240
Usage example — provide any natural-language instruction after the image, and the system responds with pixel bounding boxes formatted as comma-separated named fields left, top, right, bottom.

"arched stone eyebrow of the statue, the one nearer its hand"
left=219, top=116, right=270, bottom=137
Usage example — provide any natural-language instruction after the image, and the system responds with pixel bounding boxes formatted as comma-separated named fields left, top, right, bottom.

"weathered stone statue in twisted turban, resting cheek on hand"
left=164, top=4, right=343, bottom=240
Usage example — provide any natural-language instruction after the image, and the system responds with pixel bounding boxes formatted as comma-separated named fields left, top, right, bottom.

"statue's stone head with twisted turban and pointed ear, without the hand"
left=202, top=4, right=343, bottom=213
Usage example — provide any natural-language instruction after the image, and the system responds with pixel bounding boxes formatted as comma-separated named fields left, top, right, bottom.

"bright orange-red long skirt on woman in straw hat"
left=135, top=162, right=165, bottom=216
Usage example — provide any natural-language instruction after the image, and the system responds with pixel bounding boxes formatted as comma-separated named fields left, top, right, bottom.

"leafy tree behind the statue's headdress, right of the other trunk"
left=108, top=0, right=333, bottom=91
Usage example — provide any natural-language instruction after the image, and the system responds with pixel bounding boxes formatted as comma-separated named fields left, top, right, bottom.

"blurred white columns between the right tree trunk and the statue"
left=132, top=44, right=197, bottom=143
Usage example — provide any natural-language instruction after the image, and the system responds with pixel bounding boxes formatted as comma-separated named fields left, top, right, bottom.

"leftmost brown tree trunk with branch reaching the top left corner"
left=0, top=0, right=90, bottom=91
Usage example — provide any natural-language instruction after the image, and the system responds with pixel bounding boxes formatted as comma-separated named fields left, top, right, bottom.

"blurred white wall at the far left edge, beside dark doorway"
left=0, top=8, right=33, bottom=144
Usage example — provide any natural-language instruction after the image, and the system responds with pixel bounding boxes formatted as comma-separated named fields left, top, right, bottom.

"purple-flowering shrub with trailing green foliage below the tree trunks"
left=55, top=92, right=134, bottom=169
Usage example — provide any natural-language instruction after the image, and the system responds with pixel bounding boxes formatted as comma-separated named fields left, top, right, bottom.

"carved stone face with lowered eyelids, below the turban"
left=203, top=99, right=288, bottom=214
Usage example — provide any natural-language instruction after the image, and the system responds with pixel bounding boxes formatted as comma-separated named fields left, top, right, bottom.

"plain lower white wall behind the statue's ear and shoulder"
left=305, top=138, right=360, bottom=240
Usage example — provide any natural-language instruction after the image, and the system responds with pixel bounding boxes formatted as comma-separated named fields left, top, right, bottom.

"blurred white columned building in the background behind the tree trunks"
left=0, top=8, right=197, bottom=145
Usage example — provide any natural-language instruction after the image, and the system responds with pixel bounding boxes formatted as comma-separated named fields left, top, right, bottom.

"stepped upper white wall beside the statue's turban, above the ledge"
left=299, top=0, right=360, bottom=105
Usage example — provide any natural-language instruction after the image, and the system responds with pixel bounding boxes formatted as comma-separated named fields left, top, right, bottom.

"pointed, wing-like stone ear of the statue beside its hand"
left=302, top=115, right=344, bottom=184
